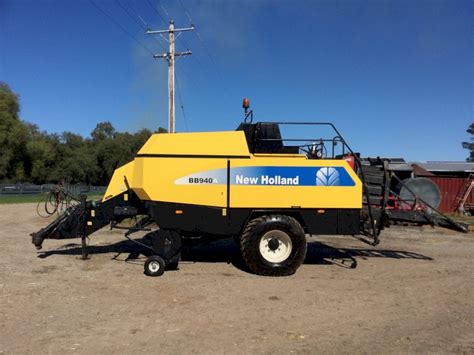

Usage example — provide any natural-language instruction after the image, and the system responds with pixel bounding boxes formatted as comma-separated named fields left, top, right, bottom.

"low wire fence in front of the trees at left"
left=0, top=184, right=107, bottom=196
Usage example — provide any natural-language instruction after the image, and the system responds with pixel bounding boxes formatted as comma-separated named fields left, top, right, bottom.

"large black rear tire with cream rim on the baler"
left=240, top=215, right=307, bottom=276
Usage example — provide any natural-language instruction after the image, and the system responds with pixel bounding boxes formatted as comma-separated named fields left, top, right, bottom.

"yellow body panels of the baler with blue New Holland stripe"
left=104, top=131, right=362, bottom=209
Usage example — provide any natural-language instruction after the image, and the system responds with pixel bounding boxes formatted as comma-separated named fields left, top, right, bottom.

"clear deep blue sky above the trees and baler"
left=0, top=0, right=474, bottom=160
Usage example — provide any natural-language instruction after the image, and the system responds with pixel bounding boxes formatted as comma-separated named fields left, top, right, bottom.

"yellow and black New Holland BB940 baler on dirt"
left=32, top=122, right=383, bottom=276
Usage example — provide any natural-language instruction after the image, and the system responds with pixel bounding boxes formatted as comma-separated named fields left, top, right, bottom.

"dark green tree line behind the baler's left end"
left=0, top=82, right=166, bottom=185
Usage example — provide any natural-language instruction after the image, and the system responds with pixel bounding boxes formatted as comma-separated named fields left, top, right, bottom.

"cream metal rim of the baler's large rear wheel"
left=259, top=230, right=293, bottom=263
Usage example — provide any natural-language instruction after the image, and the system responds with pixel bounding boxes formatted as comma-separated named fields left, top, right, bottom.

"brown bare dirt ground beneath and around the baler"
left=0, top=204, right=474, bottom=354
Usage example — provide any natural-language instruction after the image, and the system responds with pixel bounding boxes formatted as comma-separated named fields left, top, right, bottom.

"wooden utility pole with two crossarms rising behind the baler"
left=146, top=20, right=194, bottom=133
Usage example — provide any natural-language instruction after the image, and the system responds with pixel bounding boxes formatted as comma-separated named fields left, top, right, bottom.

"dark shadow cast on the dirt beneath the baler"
left=38, top=239, right=433, bottom=271
